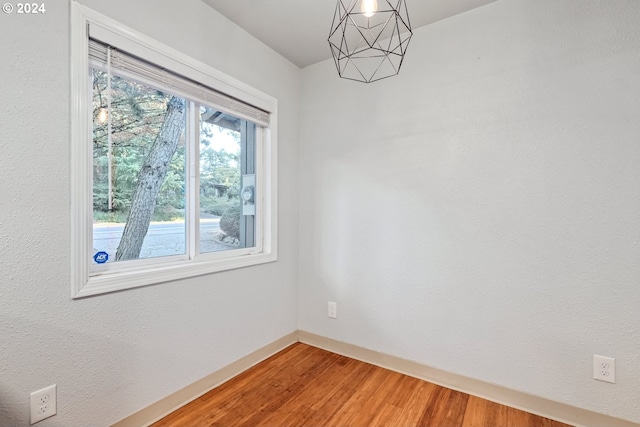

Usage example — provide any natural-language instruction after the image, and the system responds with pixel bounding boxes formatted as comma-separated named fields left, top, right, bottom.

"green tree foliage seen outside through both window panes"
left=93, top=70, right=240, bottom=224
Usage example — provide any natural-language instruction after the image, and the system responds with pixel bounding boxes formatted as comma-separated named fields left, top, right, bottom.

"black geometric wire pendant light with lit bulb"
left=329, top=0, right=413, bottom=83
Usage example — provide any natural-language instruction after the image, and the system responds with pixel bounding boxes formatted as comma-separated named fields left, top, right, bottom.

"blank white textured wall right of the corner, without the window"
left=299, top=0, right=640, bottom=422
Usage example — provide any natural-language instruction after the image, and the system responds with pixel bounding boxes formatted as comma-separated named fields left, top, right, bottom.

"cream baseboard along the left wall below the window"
left=111, top=332, right=298, bottom=427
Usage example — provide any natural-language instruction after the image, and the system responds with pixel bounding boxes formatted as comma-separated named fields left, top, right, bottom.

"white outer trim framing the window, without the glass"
left=70, top=1, right=278, bottom=298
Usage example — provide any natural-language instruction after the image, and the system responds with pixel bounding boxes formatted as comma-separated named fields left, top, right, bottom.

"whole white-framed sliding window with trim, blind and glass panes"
left=72, top=3, right=277, bottom=298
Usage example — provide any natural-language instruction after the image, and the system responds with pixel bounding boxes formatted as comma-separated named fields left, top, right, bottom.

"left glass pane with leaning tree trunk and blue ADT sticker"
left=91, top=70, right=187, bottom=265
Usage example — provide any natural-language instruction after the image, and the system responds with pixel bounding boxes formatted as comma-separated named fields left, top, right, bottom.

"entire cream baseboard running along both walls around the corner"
left=111, top=331, right=640, bottom=427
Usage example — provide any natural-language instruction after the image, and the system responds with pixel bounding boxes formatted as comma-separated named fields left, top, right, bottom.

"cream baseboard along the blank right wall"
left=298, top=331, right=640, bottom=427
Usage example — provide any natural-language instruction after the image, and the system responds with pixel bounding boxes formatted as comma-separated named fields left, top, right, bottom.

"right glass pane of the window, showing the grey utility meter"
left=200, top=107, right=255, bottom=253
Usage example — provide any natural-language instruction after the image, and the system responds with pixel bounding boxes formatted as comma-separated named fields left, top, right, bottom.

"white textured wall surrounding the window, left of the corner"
left=0, top=0, right=300, bottom=427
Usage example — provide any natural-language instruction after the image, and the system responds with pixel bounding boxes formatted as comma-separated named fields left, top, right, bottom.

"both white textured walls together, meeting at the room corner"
left=0, top=0, right=640, bottom=427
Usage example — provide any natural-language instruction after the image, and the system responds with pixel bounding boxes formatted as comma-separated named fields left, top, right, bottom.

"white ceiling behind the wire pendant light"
left=202, top=0, right=496, bottom=67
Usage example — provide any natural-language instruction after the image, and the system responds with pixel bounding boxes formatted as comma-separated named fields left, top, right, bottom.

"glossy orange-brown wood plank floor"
left=152, top=343, right=567, bottom=427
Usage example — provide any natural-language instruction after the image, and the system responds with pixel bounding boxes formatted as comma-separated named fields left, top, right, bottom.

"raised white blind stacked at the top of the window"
left=89, top=39, right=269, bottom=126
